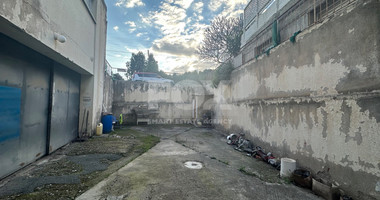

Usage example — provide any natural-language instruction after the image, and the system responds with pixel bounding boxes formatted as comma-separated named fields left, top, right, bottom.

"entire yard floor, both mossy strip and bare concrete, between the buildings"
left=0, top=125, right=319, bottom=200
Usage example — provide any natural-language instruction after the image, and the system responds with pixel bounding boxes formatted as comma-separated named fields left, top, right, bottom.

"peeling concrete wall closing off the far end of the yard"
left=112, top=81, right=211, bottom=123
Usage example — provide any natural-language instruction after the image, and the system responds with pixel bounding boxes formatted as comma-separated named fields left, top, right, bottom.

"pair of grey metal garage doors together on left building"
left=0, top=34, right=80, bottom=178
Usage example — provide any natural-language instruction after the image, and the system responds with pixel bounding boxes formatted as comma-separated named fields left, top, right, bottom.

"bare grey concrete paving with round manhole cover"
left=77, top=126, right=320, bottom=200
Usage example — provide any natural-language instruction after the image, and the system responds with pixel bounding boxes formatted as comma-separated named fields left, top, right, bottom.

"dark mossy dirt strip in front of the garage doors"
left=0, top=129, right=160, bottom=199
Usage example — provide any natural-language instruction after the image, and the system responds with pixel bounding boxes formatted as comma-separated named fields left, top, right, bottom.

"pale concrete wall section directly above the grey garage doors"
left=0, top=0, right=95, bottom=74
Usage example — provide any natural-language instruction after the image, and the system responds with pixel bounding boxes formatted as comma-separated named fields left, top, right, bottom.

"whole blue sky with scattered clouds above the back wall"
left=105, top=0, right=249, bottom=73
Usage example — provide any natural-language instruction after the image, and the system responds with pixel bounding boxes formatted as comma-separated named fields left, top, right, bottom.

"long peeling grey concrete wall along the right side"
left=214, top=0, right=380, bottom=199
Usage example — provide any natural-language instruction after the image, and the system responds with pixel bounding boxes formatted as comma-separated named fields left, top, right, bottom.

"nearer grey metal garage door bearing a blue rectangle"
left=0, top=34, right=52, bottom=177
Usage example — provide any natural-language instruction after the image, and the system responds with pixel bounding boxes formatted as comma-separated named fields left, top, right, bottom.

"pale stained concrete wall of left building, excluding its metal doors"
left=0, top=0, right=107, bottom=134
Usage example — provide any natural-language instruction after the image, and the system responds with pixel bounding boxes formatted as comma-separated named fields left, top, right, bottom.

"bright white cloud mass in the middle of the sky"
left=119, top=0, right=249, bottom=73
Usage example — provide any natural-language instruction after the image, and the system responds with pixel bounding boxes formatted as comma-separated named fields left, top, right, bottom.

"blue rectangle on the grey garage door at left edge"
left=0, top=86, right=21, bottom=143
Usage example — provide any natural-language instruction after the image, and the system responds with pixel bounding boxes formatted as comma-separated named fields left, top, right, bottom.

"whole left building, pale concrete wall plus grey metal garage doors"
left=0, top=0, right=107, bottom=178
